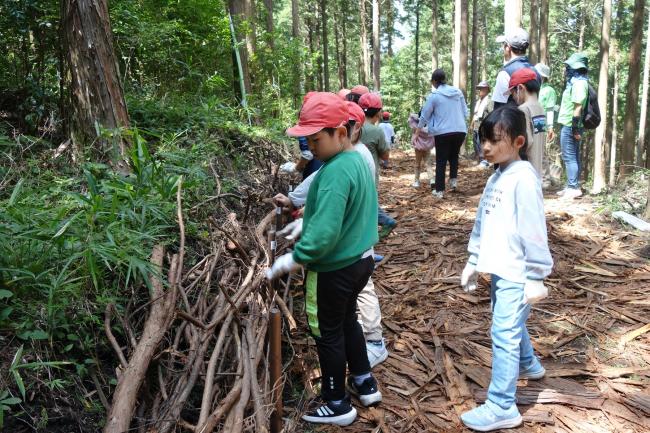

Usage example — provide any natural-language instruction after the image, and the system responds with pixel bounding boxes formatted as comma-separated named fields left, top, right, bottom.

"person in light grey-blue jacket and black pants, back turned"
left=418, top=69, right=469, bottom=198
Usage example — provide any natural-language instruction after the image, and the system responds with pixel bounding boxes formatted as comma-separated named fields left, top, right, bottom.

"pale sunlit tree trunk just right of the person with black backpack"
left=591, top=0, right=612, bottom=194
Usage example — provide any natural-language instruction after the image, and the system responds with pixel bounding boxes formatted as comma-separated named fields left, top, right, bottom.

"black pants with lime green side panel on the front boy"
left=305, top=256, right=374, bottom=400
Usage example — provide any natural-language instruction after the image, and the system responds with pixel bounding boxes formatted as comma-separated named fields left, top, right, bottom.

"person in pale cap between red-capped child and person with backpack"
left=535, top=63, right=562, bottom=188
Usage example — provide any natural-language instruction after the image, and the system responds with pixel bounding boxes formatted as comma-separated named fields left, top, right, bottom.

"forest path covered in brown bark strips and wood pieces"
left=285, top=148, right=650, bottom=433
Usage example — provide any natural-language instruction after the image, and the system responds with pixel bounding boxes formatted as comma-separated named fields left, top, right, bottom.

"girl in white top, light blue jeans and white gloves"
left=461, top=106, right=553, bottom=431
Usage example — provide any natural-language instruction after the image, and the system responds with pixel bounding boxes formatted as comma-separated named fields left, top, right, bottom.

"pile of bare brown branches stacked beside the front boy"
left=104, top=180, right=296, bottom=433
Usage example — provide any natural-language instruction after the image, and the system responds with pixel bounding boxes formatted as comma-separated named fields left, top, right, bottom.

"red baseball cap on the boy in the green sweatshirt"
left=286, top=92, right=350, bottom=137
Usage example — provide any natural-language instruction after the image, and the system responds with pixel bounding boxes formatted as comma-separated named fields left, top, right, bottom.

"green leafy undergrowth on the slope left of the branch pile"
left=0, top=100, right=282, bottom=431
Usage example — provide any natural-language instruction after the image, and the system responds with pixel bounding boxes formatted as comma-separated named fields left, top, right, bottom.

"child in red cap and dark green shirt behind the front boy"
left=359, top=93, right=397, bottom=239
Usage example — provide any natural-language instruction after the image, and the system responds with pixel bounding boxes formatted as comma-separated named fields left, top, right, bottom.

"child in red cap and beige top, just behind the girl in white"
left=506, top=68, right=546, bottom=178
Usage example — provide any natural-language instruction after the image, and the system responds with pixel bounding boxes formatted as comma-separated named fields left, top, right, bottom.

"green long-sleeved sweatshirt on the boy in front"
left=293, top=151, right=378, bottom=272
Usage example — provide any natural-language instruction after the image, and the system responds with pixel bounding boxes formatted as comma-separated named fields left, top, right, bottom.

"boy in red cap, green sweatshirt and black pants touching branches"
left=266, top=92, right=382, bottom=425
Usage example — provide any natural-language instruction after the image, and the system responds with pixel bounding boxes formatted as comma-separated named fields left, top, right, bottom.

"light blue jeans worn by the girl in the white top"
left=488, top=275, right=535, bottom=409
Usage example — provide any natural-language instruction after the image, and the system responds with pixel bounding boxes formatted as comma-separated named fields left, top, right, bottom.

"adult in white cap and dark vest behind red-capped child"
left=492, top=28, right=542, bottom=108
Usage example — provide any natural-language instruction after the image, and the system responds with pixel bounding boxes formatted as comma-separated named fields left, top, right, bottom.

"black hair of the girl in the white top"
left=478, top=105, right=528, bottom=160
